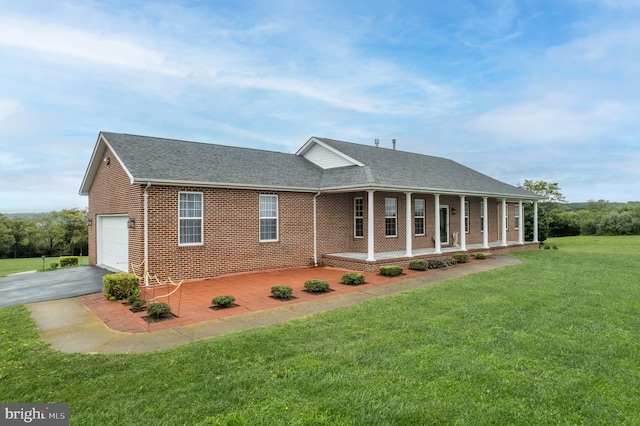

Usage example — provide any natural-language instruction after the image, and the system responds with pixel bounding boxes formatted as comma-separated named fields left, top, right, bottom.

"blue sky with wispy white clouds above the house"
left=0, top=0, right=640, bottom=213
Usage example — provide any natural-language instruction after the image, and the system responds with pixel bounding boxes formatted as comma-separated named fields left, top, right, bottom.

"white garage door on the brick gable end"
left=97, top=215, right=129, bottom=272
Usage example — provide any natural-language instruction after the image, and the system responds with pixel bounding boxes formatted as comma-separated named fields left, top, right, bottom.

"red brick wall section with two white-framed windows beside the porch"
left=144, top=186, right=313, bottom=279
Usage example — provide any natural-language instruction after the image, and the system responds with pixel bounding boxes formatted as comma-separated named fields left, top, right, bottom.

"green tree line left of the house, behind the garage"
left=0, top=209, right=89, bottom=258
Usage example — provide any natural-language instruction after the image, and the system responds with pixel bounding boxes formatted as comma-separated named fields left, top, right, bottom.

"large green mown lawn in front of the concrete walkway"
left=0, top=237, right=640, bottom=425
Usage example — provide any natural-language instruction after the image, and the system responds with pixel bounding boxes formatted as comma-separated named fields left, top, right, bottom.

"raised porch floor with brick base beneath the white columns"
left=322, top=241, right=540, bottom=271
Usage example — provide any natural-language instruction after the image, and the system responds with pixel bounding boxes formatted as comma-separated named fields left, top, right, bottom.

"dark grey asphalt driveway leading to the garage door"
left=0, top=266, right=111, bottom=307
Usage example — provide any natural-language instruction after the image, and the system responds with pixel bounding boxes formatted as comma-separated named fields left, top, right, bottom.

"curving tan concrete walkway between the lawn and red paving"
left=26, top=256, right=520, bottom=353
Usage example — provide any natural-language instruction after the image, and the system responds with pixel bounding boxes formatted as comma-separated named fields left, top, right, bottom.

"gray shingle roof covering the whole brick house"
left=80, top=132, right=539, bottom=199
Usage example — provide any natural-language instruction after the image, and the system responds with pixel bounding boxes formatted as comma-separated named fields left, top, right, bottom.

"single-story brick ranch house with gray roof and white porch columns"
left=80, top=132, right=540, bottom=279
